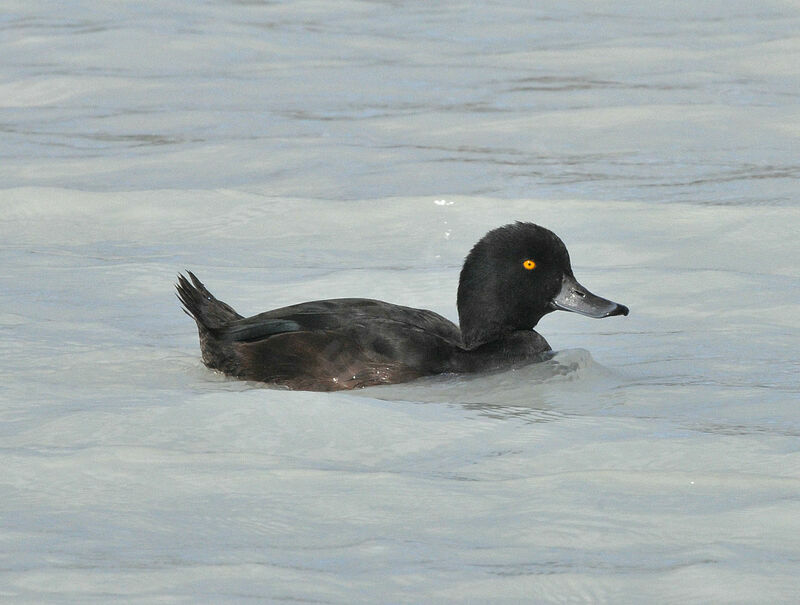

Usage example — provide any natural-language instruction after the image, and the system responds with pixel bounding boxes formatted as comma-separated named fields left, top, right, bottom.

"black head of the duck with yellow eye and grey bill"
left=458, top=223, right=628, bottom=349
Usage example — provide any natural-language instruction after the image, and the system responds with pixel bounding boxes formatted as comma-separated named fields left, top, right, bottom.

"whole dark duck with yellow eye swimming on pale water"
left=176, top=222, right=629, bottom=391
